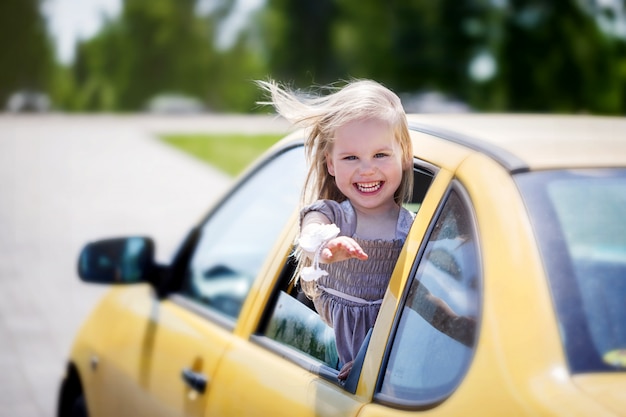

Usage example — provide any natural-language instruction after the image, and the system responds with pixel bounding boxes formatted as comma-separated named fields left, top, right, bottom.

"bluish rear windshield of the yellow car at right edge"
left=515, top=169, right=626, bottom=372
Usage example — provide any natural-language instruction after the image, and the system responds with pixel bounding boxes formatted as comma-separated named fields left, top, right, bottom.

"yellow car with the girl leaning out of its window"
left=58, top=115, right=626, bottom=417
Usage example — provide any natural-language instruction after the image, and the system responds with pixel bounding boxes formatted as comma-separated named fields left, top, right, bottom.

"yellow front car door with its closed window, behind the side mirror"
left=144, top=141, right=306, bottom=416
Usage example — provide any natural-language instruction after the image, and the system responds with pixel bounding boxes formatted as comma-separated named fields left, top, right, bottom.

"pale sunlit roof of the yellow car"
left=407, top=113, right=626, bottom=172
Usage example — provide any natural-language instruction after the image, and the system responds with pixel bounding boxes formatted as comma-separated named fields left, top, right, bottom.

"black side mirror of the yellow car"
left=78, top=237, right=154, bottom=284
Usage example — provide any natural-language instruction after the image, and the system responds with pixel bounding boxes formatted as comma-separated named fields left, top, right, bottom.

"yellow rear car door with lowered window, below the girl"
left=200, top=161, right=433, bottom=417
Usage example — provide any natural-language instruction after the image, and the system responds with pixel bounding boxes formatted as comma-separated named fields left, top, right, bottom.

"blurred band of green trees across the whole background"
left=0, top=0, right=626, bottom=114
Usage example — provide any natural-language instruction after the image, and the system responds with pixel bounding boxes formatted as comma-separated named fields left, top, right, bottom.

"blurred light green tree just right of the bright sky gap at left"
left=73, top=0, right=214, bottom=111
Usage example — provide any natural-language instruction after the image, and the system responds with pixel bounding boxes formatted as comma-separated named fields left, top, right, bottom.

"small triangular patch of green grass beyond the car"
left=161, top=133, right=284, bottom=176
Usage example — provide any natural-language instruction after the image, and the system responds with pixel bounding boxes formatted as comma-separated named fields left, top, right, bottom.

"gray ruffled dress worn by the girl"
left=300, top=200, right=414, bottom=365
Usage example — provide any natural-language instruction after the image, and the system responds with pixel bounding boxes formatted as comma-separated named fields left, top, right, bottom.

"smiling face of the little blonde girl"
left=326, top=119, right=402, bottom=214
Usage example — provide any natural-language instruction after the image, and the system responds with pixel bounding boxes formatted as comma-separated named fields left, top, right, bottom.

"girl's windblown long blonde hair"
left=258, top=80, right=413, bottom=205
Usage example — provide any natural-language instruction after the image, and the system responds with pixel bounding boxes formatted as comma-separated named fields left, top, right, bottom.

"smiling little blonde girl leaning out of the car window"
left=259, top=80, right=413, bottom=379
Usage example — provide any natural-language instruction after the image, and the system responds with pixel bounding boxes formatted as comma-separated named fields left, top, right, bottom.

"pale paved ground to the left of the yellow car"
left=0, top=115, right=288, bottom=417
